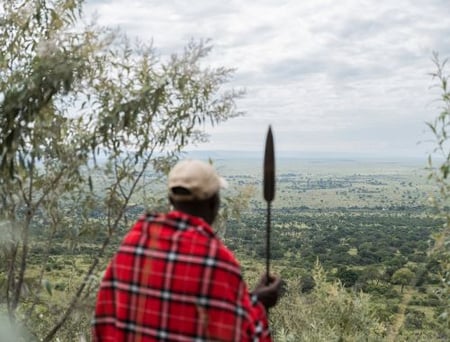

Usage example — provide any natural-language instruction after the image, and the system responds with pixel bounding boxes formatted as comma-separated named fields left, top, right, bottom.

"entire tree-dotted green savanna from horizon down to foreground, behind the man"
left=17, top=159, right=445, bottom=341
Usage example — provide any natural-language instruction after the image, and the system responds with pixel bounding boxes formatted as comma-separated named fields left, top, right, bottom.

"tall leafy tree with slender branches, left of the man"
left=0, top=0, right=241, bottom=341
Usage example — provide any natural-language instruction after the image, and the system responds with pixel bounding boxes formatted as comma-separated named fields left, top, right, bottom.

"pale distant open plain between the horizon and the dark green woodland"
left=218, top=159, right=433, bottom=209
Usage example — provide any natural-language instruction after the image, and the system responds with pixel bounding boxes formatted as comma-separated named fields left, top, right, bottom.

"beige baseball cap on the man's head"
left=168, top=159, right=228, bottom=201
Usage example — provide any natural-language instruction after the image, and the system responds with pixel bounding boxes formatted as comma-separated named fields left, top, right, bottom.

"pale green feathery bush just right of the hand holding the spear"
left=271, top=263, right=386, bottom=341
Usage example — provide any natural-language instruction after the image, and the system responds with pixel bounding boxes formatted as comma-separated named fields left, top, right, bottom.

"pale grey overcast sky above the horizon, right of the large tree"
left=85, top=0, right=450, bottom=158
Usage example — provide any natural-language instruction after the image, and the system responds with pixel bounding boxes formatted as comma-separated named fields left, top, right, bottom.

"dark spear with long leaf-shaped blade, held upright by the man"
left=263, top=125, right=275, bottom=284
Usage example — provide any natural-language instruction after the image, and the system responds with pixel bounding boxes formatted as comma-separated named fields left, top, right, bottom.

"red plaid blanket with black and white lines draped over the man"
left=92, top=211, right=271, bottom=342
